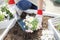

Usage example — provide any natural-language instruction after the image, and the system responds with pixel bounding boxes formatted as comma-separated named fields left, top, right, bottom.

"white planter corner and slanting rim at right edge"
left=48, top=17, right=60, bottom=40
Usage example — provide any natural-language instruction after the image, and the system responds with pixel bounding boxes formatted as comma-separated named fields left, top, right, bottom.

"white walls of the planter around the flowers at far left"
left=0, top=6, right=16, bottom=29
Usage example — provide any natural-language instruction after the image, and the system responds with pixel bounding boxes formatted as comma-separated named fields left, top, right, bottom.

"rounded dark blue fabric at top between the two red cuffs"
left=16, top=0, right=32, bottom=10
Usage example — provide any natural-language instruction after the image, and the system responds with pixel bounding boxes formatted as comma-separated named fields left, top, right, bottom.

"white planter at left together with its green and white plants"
left=0, top=6, right=16, bottom=29
